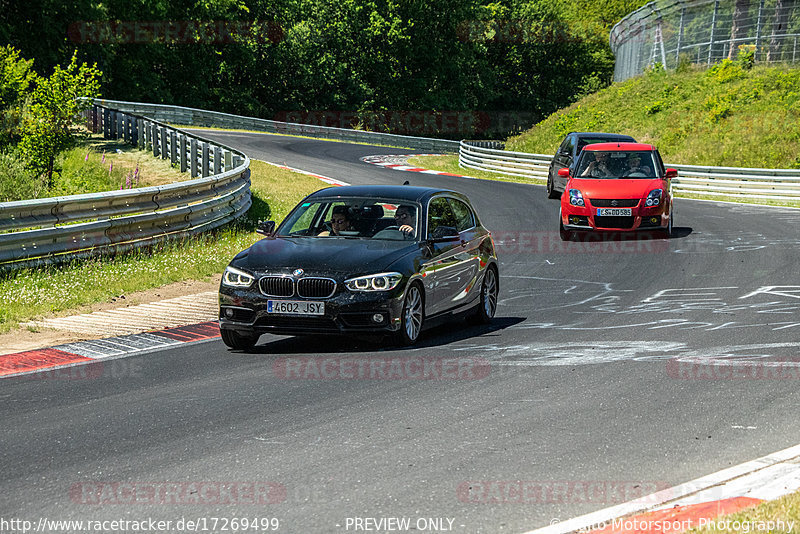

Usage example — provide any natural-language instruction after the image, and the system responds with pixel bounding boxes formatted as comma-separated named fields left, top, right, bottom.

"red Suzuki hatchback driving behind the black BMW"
left=558, top=143, right=678, bottom=240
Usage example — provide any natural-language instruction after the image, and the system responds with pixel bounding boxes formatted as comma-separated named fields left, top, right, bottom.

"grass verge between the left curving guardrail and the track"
left=0, top=160, right=327, bottom=333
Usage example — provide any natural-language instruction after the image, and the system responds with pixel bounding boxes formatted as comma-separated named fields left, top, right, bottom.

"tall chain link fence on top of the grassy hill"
left=609, top=0, right=800, bottom=82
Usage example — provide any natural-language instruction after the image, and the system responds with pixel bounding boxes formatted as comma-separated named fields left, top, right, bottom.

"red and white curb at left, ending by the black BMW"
left=0, top=321, right=219, bottom=378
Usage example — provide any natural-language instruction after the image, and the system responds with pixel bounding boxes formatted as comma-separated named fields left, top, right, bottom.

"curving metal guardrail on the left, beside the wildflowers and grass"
left=0, top=104, right=251, bottom=270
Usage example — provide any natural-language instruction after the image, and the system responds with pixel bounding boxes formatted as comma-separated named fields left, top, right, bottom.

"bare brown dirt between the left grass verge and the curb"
left=0, top=276, right=220, bottom=355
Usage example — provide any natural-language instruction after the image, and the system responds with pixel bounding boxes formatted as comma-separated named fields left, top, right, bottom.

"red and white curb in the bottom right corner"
left=526, top=445, right=800, bottom=534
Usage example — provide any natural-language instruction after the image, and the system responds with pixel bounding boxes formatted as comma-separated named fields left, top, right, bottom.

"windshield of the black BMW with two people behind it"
left=277, top=197, right=420, bottom=241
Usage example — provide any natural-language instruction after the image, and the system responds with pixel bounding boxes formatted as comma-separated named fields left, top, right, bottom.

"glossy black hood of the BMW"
left=231, top=237, right=420, bottom=276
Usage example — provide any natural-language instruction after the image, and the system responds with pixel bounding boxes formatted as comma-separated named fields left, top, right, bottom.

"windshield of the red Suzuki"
left=575, top=150, right=658, bottom=179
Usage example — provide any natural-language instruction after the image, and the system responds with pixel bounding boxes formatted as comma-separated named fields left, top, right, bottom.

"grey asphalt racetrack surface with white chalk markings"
left=0, top=132, right=800, bottom=533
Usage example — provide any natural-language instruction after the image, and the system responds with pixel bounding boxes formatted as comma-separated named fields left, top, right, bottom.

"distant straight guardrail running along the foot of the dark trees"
left=98, top=100, right=459, bottom=153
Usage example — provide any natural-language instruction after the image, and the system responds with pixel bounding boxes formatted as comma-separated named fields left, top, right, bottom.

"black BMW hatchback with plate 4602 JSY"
left=219, top=186, right=499, bottom=350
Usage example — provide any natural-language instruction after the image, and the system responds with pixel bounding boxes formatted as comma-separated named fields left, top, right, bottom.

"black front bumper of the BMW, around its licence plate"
left=219, top=282, right=407, bottom=335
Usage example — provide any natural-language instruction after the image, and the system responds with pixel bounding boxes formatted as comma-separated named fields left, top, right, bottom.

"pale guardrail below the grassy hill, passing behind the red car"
left=458, top=141, right=800, bottom=201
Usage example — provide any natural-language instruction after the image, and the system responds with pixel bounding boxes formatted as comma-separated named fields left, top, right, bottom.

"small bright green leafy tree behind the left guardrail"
left=19, top=54, right=101, bottom=188
